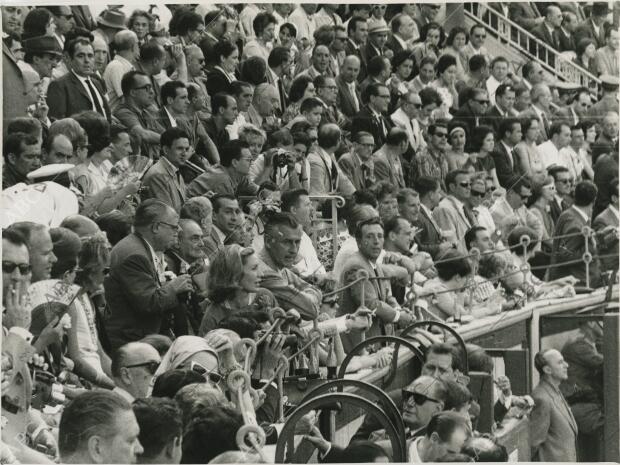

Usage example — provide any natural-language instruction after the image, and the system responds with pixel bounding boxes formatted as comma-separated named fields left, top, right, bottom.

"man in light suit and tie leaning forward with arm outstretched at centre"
left=337, top=218, right=413, bottom=352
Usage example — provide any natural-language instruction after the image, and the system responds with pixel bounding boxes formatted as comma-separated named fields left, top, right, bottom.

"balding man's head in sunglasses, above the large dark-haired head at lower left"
left=112, top=342, right=161, bottom=402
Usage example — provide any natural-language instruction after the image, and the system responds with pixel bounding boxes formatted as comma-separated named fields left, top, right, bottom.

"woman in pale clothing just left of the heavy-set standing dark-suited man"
left=68, top=233, right=114, bottom=389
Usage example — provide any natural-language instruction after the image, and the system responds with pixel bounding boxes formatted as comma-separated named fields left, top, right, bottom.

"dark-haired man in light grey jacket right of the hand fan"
left=143, top=128, right=191, bottom=212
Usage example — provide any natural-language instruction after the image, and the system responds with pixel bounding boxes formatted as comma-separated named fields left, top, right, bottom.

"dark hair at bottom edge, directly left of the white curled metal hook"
left=181, top=406, right=243, bottom=463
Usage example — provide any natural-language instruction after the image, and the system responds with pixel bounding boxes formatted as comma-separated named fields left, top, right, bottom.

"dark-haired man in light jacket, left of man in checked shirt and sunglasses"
left=372, top=128, right=409, bottom=188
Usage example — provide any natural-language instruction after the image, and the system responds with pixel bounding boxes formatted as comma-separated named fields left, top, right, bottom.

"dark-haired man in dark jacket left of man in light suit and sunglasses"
left=413, top=176, right=453, bottom=259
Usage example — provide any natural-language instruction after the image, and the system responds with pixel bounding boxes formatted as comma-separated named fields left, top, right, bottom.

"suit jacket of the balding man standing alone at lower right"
left=530, top=380, right=577, bottom=462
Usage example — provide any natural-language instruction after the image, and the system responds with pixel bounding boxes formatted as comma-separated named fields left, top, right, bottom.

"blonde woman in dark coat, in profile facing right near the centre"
left=199, top=244, right=277, bottom=335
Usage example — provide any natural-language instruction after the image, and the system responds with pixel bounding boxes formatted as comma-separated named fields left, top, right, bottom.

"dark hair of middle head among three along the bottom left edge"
left=133, top=397, right=183, bottom=458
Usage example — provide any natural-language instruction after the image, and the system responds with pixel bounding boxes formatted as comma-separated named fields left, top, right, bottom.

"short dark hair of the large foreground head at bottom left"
left=58, top=390, right=131, bottom=459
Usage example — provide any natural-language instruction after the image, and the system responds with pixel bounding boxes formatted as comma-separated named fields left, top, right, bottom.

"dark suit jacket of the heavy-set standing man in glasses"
left=103, top=234, right=179, bottom=349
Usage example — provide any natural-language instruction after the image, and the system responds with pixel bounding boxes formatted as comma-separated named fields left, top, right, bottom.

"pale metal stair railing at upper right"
left=465, top=3, right=600, bottom=88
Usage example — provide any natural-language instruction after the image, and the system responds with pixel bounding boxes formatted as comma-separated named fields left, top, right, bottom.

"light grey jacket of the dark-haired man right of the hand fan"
left=142, top=157, right=187, bottom=212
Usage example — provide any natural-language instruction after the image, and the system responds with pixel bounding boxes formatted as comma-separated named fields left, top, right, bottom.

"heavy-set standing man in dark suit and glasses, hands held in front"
left=103, top=199, right=193, bottom=349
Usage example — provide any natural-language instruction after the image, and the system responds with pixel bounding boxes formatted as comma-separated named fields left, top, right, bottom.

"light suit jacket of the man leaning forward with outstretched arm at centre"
left=336, top=251, right=407, bottom=353
